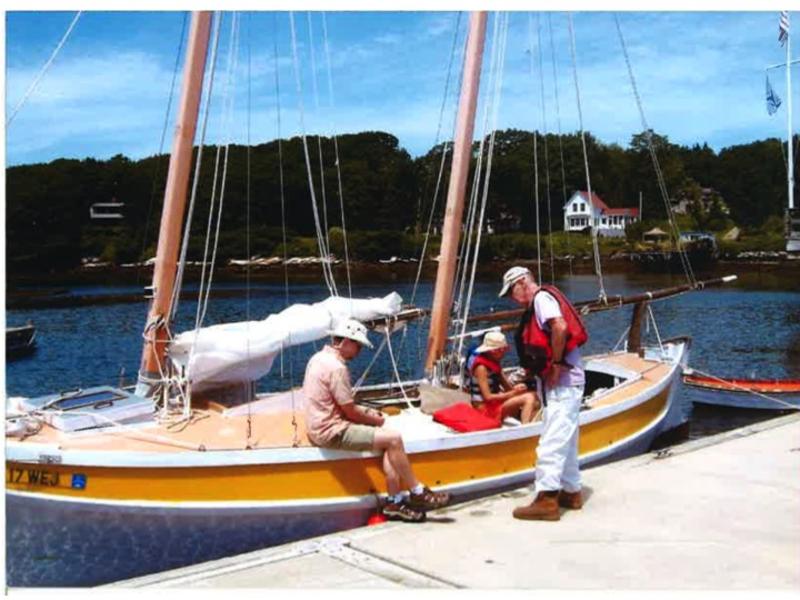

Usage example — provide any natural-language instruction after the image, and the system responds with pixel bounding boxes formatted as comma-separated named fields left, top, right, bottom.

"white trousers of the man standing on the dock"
left=535, top=386, right=583, bottom=494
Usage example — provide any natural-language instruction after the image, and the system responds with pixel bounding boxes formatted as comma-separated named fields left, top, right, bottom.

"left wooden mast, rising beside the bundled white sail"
left=136, top=11, right=211, bottom=396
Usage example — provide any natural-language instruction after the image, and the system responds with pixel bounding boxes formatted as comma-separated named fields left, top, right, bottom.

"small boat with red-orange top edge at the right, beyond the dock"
left=683, top=372, right=800, bottom=410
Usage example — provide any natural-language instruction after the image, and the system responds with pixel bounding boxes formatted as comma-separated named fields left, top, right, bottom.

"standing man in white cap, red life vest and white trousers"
left=500, top=267, right=587, bottom=521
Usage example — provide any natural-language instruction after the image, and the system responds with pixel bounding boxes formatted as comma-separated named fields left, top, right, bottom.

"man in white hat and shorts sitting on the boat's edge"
left=303, top=319, right=450, bottom=523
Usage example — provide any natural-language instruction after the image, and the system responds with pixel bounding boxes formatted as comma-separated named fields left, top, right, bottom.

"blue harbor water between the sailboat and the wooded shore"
left=6, top=274, right=800, bottom=438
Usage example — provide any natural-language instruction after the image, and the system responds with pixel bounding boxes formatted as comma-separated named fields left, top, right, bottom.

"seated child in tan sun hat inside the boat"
left=467, top=331, right=539, bottom=427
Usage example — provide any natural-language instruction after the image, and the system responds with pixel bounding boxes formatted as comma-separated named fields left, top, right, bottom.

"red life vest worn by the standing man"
left=514, top=285, right=589, bottom=376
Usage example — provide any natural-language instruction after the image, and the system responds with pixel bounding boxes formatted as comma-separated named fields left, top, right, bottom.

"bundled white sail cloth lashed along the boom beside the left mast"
left=168, top=292, right=403, bottom=391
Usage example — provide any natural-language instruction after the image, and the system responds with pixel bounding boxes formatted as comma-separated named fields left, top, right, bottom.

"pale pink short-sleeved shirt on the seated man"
left=303, top=346, right=353, bottom=446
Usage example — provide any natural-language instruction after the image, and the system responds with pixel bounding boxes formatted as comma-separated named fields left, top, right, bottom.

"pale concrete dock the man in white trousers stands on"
left=111, top=413, right=800, bottom=592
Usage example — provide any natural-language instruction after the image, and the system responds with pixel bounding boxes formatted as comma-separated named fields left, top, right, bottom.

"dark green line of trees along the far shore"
left=6, top=129, right=786, bottom=274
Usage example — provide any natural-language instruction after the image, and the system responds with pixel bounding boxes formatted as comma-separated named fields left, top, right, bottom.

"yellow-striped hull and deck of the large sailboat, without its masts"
left=6, top=339, right=688, bottom=586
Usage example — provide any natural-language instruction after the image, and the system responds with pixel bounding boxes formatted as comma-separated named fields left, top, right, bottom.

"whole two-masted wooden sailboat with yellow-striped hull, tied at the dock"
left=6, top=12, right=732, bottom=586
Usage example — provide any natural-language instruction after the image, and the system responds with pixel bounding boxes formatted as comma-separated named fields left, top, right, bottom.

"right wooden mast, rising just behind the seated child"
left=425, top=11, right=486, bottom=373
